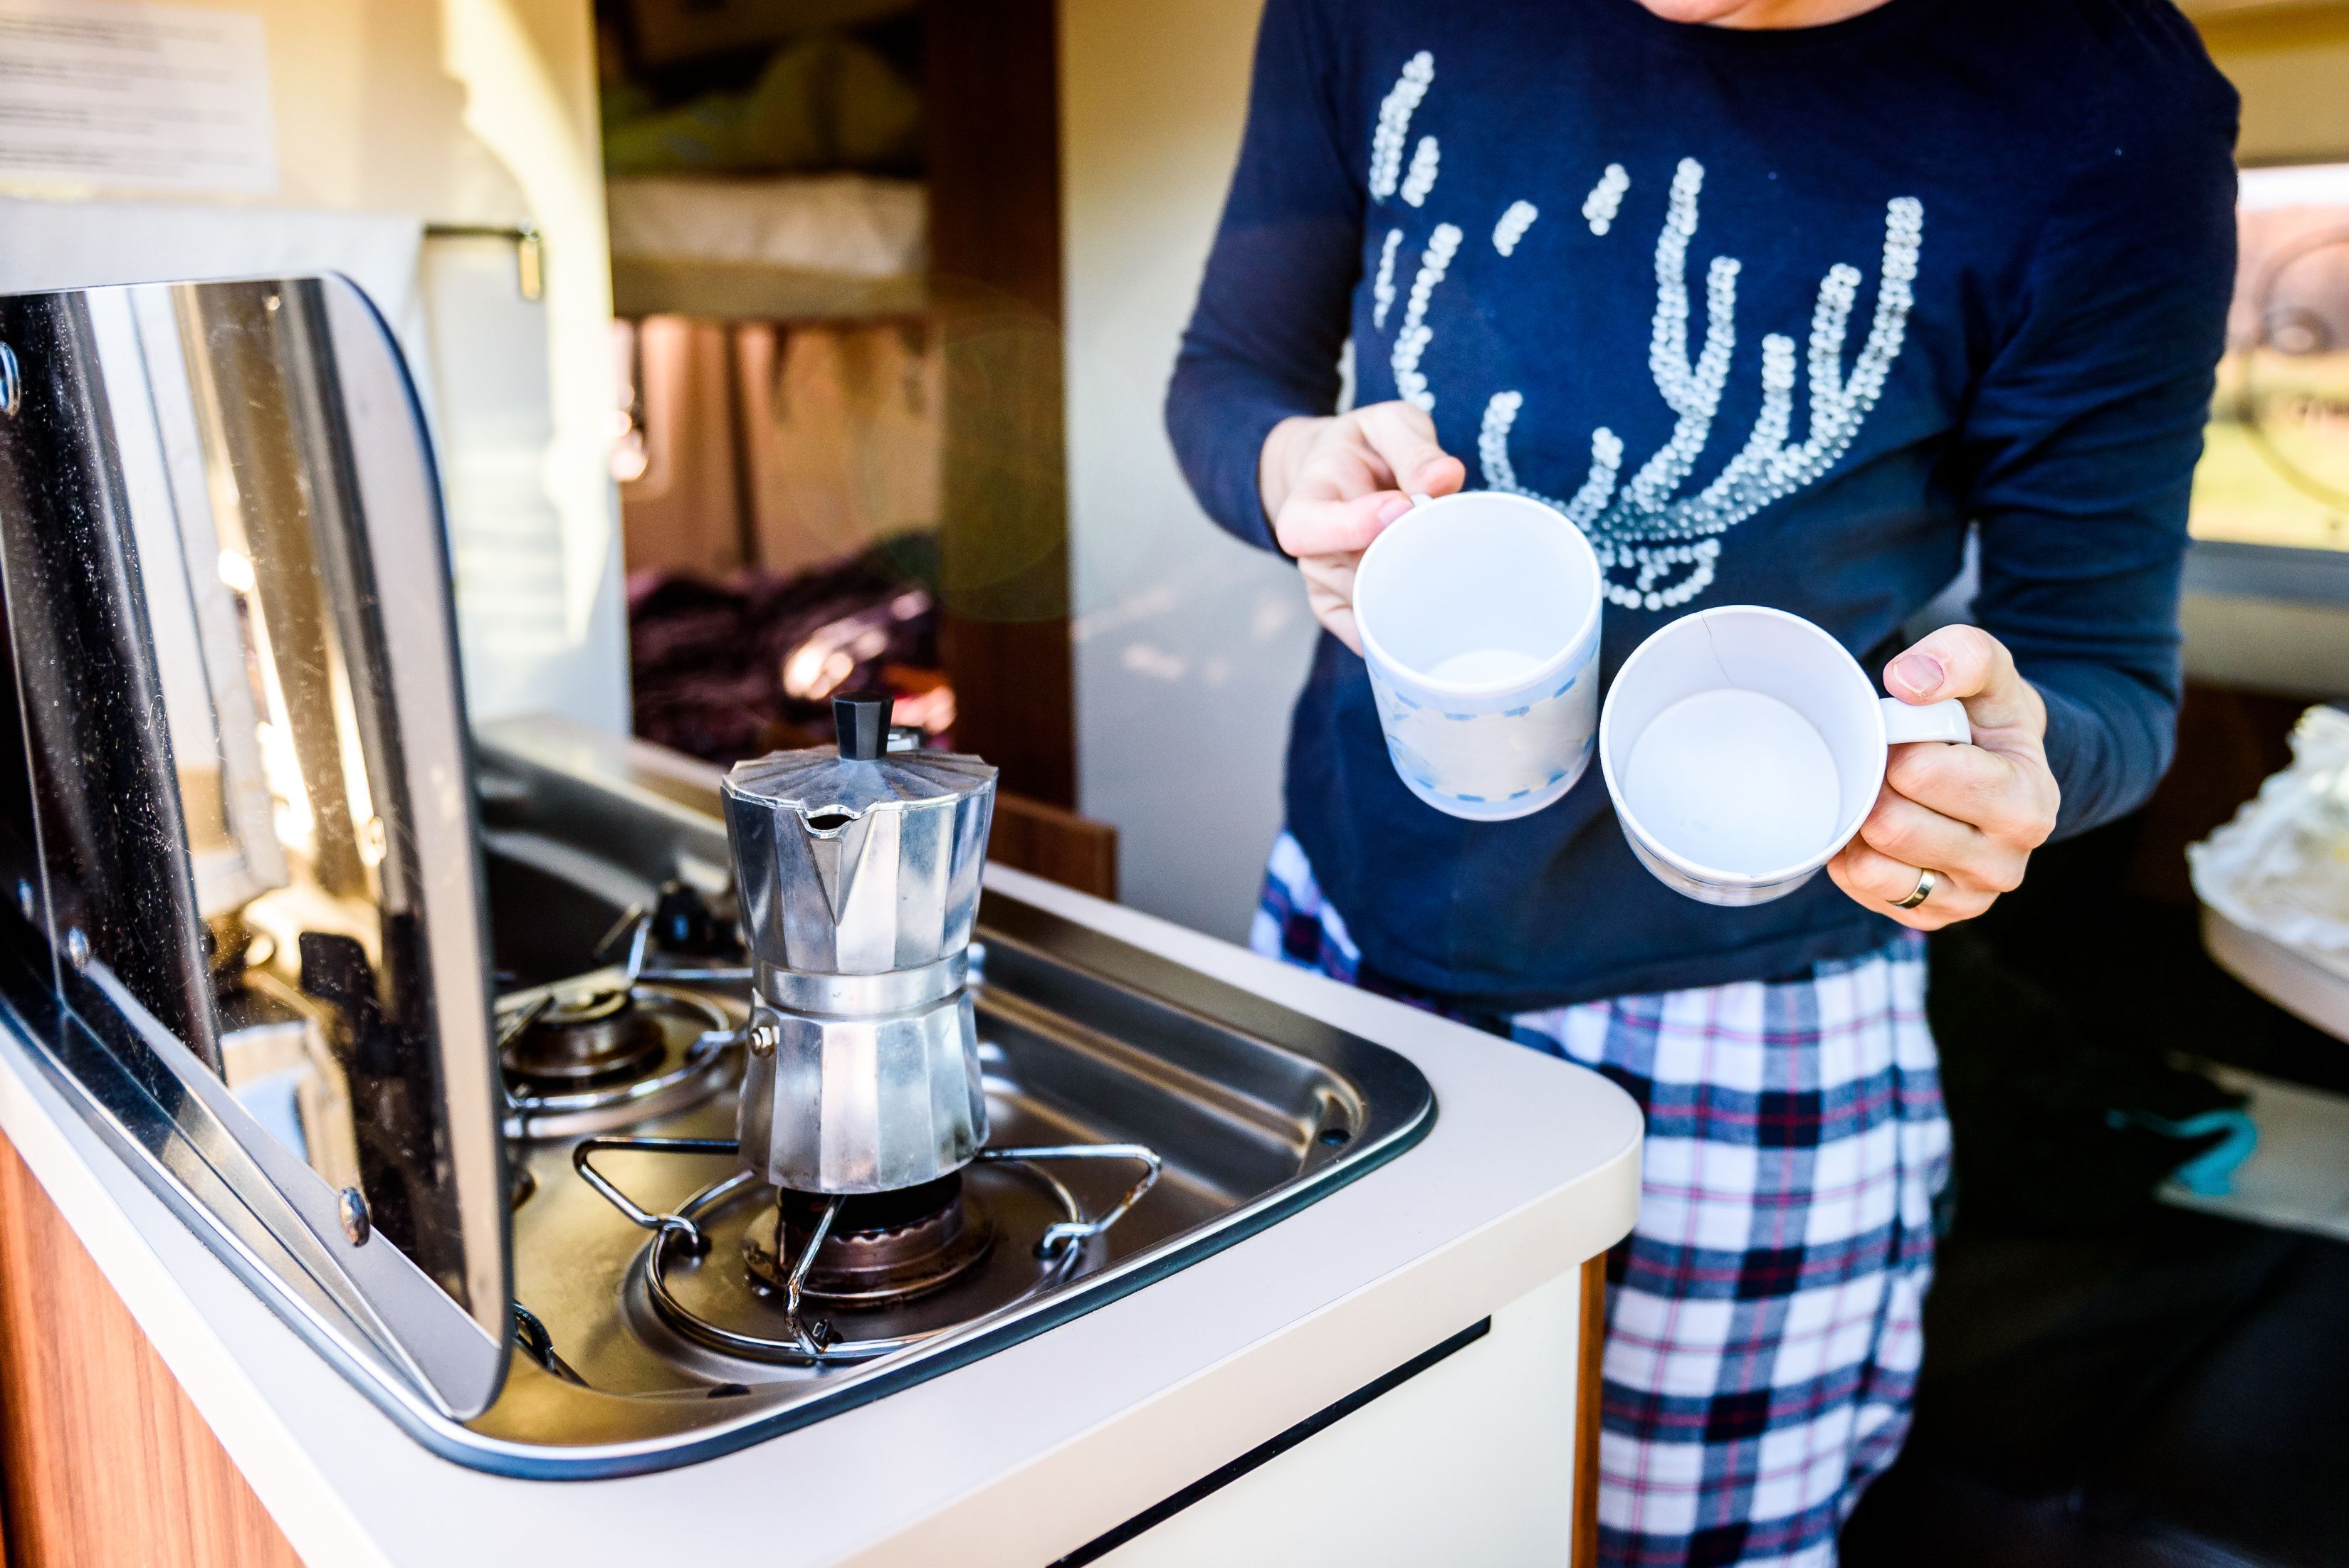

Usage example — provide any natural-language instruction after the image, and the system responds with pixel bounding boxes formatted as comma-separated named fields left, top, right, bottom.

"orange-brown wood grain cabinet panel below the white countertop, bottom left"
left=0, top=1138, right=300, bottom=1568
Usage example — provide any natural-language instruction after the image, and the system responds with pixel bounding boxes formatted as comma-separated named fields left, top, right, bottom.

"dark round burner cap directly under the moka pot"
left=742, top=1172, right=996, bottom=1305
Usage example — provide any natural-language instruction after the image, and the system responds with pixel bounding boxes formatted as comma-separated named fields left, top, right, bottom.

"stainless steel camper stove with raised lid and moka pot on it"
left=0, top=279, right=1435, bottom=1476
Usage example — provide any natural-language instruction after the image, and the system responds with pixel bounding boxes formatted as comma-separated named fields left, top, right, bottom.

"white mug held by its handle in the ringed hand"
left=1599, top=606, right=1973, bottom=904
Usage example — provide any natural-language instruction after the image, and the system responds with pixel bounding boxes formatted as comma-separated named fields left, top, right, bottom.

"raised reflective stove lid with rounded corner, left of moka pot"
left=0, top=277, right=512, bottom=1416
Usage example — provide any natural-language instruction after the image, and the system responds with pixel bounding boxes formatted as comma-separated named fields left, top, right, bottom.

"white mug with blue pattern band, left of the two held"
left=1353, top=490, right=1599, bottom=821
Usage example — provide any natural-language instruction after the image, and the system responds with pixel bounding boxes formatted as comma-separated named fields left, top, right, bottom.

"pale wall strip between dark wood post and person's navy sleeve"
left=1059, top=0, right=1313, bottom=937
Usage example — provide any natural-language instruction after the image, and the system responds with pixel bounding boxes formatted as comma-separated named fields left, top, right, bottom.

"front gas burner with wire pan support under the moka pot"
left=571, top=1138, right=1160, bottom=1366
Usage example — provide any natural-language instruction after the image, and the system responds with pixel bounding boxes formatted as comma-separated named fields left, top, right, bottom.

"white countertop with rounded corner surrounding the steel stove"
left=0, top=866, right=1639, bottom=1568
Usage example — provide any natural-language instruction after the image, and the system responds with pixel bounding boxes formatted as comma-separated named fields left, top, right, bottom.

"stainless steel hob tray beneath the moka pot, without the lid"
left=448, top=723, right=1433, bottom=1476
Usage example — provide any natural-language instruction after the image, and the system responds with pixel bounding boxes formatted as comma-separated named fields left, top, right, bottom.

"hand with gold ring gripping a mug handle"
left=1827, top=627, right=2060, bottom=932
